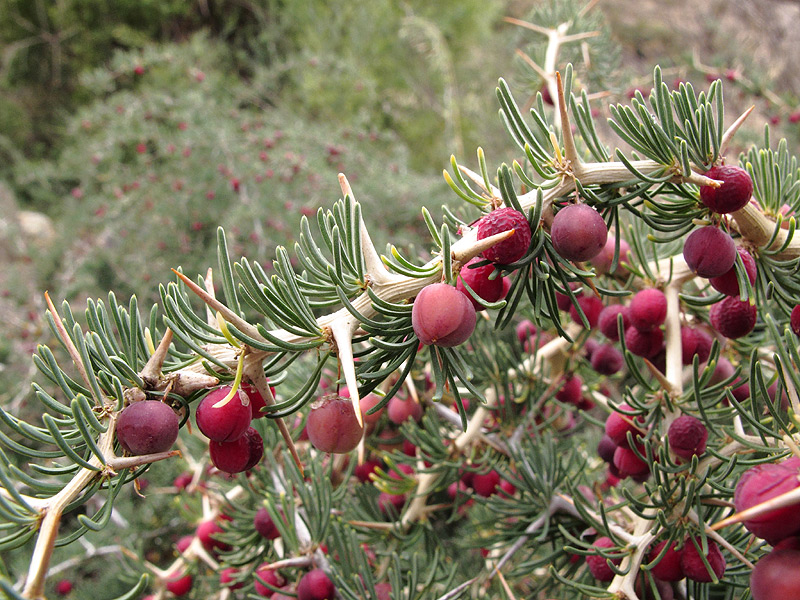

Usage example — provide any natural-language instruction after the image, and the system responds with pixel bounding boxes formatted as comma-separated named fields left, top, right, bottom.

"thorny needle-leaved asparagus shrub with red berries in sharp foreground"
left=0, top=4, right=800, bottom=600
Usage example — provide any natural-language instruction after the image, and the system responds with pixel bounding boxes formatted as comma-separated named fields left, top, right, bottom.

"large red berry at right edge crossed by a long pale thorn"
left=733, top=463, right=800, bottom=545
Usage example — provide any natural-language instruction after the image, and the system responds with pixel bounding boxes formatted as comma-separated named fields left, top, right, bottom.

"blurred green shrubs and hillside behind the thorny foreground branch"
left=0, top=0, right=800, bottom=592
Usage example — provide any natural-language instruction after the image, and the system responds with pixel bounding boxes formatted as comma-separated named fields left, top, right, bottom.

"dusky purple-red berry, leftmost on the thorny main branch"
left=116, top=400, right=180, bottom=456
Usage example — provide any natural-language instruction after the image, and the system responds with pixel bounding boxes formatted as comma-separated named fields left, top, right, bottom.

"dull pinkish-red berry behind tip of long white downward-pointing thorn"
left=306, top=392, right=362, bottom=454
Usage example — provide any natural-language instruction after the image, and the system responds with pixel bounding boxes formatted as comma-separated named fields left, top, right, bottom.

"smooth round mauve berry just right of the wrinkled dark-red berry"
left=550, top=204, right=608, bottom=261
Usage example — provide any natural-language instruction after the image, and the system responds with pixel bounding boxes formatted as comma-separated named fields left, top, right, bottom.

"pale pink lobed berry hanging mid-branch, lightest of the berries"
left=411, top=283, right=477, bottom=348
